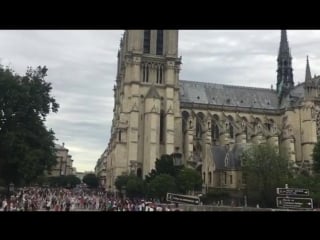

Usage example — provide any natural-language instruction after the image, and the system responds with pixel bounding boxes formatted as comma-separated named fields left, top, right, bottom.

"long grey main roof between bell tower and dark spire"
left=180, top=80, right=278, bottom=110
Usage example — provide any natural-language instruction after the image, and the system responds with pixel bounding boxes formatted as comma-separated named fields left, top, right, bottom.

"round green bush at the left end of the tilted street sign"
left=148, top=174, right=176, bottom=201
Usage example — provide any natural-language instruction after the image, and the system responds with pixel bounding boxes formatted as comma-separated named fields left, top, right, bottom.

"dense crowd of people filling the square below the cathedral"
left=0, top=187, right=180, bottom=212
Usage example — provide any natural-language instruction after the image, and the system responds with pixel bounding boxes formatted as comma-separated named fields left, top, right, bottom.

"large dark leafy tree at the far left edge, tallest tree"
left=0, top=66, right=59, bottom=185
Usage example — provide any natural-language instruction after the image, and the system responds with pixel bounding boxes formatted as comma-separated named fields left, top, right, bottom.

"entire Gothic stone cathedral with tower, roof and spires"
left=96, top=30, right=320, bottom=190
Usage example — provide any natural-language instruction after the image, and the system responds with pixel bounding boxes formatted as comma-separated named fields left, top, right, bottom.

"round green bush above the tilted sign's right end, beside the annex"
left=177, top=168, right=202, bottom=194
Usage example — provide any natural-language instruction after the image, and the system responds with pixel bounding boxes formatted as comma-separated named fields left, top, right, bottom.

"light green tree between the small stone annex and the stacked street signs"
left=242, top=144, right=291, bottom=207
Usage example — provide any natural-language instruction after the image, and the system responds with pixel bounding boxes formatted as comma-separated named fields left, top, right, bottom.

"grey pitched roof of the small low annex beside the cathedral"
left=211, top=144, right=247, bottom=170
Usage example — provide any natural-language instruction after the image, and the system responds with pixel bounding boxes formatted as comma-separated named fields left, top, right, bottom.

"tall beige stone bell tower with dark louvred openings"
left=116, top=30, right=181, bottom=177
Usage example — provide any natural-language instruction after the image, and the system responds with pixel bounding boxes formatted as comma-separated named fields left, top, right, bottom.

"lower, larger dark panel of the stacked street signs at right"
left=277, top=197, right=313, bottom=209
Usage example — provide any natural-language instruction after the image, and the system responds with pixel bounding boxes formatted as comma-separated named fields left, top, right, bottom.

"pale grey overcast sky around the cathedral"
left=0, top=30, right=320, bottom=171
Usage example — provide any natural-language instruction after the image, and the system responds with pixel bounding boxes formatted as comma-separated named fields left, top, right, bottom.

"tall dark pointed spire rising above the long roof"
left=277, top=30, right=294, bottom=100
